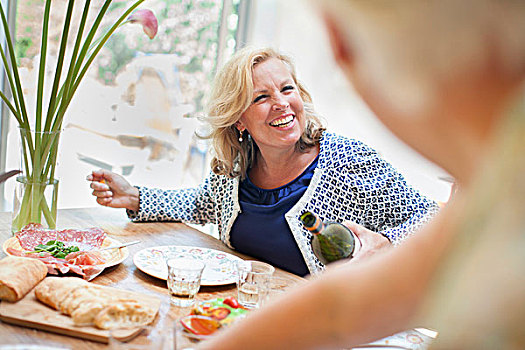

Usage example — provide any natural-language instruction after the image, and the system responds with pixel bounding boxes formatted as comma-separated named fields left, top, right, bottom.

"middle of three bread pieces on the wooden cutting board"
left=35, top=277, right=88, bottom=310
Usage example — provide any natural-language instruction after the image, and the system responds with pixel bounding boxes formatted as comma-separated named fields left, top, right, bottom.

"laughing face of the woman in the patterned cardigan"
left=237, top=58, right=305, bottom=152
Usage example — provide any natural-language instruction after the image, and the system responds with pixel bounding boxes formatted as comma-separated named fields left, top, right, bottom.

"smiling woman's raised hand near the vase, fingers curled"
left=86, top=169, right=139, bottom=211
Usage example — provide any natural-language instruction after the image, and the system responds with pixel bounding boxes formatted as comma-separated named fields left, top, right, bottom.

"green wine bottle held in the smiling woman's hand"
left=300, top=211, right=360, bottom=265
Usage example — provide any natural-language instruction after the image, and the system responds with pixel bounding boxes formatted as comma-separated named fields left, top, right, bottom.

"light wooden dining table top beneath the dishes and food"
left=0, top=207, right=303, bottom=349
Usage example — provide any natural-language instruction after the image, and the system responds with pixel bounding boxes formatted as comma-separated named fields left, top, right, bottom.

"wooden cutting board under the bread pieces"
left=0, top=289, right=160, bottom=343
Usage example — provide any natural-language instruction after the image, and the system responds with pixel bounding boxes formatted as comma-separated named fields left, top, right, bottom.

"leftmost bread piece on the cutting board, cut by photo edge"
left=0, top=256, right=47, bottom=302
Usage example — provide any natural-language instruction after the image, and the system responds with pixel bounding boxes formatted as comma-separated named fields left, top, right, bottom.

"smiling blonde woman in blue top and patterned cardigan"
left=88, top=48, right=437, bottom=276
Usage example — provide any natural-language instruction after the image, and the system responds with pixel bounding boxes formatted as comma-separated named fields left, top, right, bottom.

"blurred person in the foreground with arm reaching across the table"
left=202, top=0, right=525, bottom=349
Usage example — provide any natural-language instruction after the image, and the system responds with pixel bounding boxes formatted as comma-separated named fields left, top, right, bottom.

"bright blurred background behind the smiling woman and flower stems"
left=0, top=0, right=451, bottom=211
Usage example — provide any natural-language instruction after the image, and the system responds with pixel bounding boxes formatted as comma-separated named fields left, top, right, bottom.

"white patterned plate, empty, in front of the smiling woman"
left=133, top=245, right=242, bottom=286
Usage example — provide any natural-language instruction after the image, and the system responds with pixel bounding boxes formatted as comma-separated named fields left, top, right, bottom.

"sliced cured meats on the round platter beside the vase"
left=11, top=224, right=106, bottom=281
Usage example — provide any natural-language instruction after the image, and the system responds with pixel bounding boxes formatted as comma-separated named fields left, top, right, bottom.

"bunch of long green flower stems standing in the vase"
left=4, top=0, right=151, bottom=229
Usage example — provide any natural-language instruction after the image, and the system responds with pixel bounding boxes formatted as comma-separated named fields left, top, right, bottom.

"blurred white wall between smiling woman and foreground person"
left=248, top=0, right=450, bottom=201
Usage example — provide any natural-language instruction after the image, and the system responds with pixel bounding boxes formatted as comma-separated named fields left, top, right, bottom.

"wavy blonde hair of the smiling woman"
left=201, top=47, right=325, bottom=178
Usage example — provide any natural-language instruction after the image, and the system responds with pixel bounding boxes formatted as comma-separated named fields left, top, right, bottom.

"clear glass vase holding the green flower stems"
left=11, top=128, right=60, bottom=233
